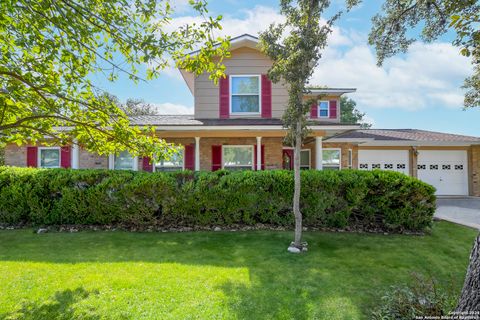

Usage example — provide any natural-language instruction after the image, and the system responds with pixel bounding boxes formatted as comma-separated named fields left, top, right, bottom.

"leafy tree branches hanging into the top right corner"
left=369, top=0, right=480, bottom=108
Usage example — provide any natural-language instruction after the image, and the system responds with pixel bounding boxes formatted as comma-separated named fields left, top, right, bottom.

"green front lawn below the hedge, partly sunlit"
left=0, top=222, right=476, bottom=319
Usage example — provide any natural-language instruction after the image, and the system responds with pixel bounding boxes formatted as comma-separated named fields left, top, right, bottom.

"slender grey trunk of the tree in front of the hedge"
left=293, top=121, right=302, bottom=249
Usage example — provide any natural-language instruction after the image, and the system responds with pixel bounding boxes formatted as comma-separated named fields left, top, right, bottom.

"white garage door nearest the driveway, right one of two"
left=417, top=150, right=468, bottom=195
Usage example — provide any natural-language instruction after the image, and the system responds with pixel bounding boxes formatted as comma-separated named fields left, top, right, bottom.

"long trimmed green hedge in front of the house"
left=0, top=167, right=435, bottom=231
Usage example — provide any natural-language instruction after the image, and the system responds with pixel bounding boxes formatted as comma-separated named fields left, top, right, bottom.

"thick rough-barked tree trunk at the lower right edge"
left=455, top=234, right=480, bottom=315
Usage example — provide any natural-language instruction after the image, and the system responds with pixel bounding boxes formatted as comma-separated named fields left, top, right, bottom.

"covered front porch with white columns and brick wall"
left=156, top=136, right=358, bottom=171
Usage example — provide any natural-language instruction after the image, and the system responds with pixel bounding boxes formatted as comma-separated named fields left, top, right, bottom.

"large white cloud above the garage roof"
left=312, top=43, right=471, bottom=110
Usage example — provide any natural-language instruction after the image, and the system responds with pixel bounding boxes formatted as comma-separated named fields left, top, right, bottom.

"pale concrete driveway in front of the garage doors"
left=435, top=197, right=480, bottom=230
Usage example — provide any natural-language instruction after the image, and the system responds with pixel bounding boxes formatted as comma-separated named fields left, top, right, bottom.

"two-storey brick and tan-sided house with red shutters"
left=5, top=35, right=480, bottom=196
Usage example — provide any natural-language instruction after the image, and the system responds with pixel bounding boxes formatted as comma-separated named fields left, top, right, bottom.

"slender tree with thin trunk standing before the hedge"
left=260, top=0, right=356, bottom=251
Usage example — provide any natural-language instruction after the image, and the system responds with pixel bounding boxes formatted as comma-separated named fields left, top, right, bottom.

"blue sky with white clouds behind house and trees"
left=94, top=0, right=480, bottom=136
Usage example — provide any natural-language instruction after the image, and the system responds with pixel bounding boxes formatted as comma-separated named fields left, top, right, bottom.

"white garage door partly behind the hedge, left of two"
left=358, top=150, right=410, bottom=175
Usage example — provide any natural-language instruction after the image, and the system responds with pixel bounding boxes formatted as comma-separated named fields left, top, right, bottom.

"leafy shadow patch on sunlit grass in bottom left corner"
left=0, top=288, right=100, bottom=320
